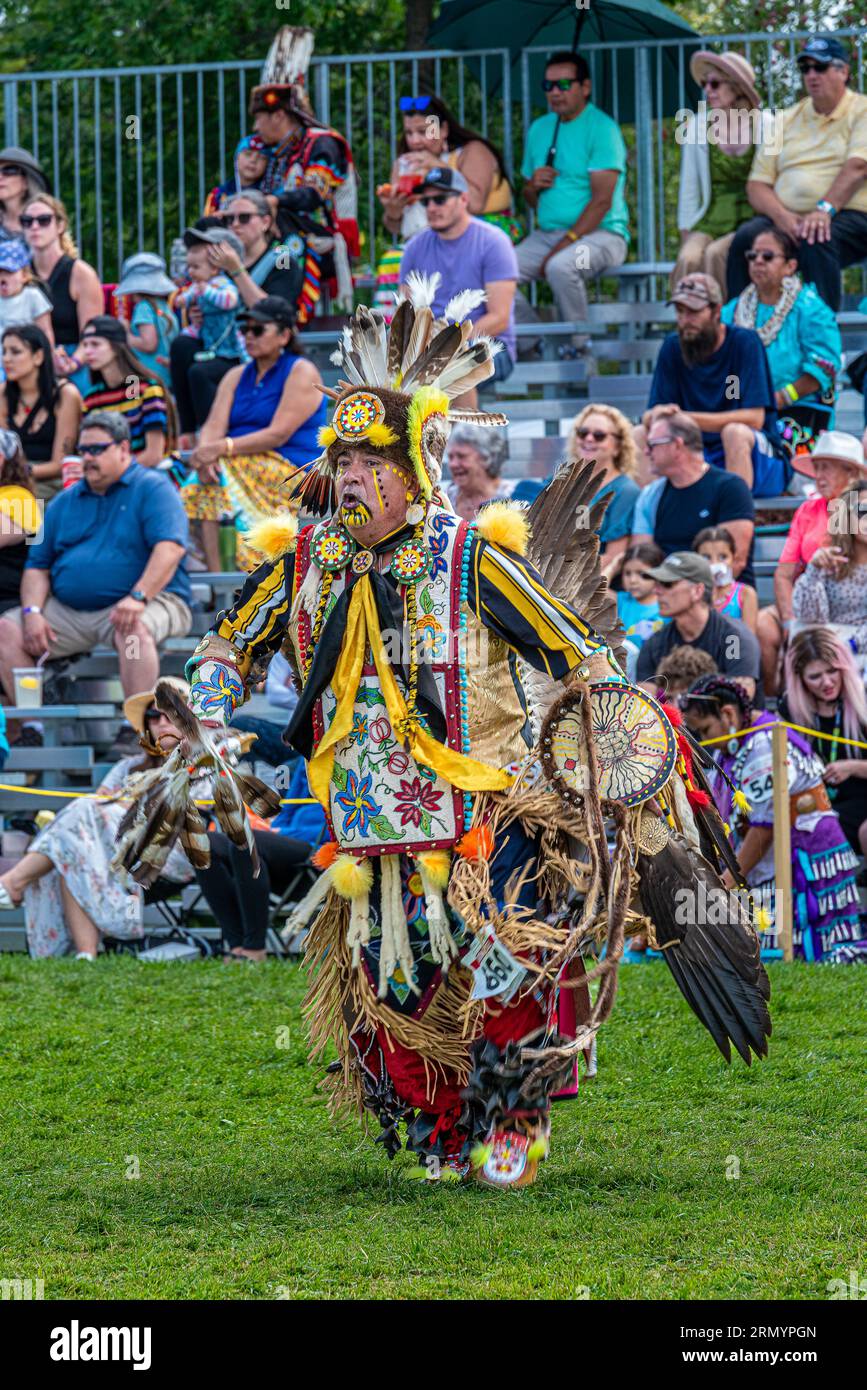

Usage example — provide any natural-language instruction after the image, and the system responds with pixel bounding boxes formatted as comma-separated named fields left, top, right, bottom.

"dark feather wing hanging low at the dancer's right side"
left=638, top=834, right=771, bottom=1066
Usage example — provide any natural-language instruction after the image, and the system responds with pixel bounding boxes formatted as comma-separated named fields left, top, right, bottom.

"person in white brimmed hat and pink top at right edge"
left=757, top=430, right=867, bottom=695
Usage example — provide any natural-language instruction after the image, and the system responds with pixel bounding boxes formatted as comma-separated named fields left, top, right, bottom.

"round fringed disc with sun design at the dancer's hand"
left=540, top=681, right=678, bottom=806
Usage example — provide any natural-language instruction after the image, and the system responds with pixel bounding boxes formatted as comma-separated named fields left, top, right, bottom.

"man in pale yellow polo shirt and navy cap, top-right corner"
left=728, top=35, right=867, bottom=313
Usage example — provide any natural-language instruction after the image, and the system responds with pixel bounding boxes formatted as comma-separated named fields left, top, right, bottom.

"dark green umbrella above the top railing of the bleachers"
left=429, top=0, right=702, bottom=124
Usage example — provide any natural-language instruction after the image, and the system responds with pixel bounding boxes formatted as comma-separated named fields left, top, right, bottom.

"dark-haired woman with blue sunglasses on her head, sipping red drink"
left=377, top=96, right=514, bottom=242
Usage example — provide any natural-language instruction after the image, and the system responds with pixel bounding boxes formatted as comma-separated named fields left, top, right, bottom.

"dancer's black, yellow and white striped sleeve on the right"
left=467, top=537, right=606, bottom=680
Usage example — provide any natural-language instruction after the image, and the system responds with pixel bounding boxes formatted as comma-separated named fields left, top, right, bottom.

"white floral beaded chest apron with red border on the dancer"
left=296, top=507, right=472, bottom=855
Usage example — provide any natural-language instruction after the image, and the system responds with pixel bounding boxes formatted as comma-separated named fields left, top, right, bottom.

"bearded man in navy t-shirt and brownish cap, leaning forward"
left=645, top=271, right=792, bottom=498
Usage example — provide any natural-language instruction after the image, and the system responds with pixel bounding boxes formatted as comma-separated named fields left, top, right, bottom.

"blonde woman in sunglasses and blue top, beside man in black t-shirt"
left=567, top=404, right=641, bottom=574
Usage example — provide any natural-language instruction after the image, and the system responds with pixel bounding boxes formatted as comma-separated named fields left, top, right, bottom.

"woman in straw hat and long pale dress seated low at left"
left=0, top=676, right=197, bottom=960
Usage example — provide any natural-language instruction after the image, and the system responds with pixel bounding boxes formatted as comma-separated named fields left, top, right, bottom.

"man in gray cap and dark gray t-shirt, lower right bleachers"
left=636, top=550, right=760, bottom=698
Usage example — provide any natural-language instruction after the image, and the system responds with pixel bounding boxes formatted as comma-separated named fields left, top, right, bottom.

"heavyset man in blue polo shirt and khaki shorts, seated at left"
left=0, top=410, right=192, bottom=717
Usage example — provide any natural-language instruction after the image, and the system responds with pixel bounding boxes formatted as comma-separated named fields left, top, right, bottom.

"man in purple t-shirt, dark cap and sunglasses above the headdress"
left=400, top=165, right=518, bottom=410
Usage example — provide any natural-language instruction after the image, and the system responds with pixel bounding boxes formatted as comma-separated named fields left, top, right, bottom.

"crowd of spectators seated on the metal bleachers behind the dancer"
left=0, top=35, right=867, bottom=959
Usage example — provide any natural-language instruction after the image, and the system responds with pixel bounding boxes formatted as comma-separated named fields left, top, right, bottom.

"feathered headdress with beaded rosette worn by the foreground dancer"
left=299, top=271, right=507, bottom=514
